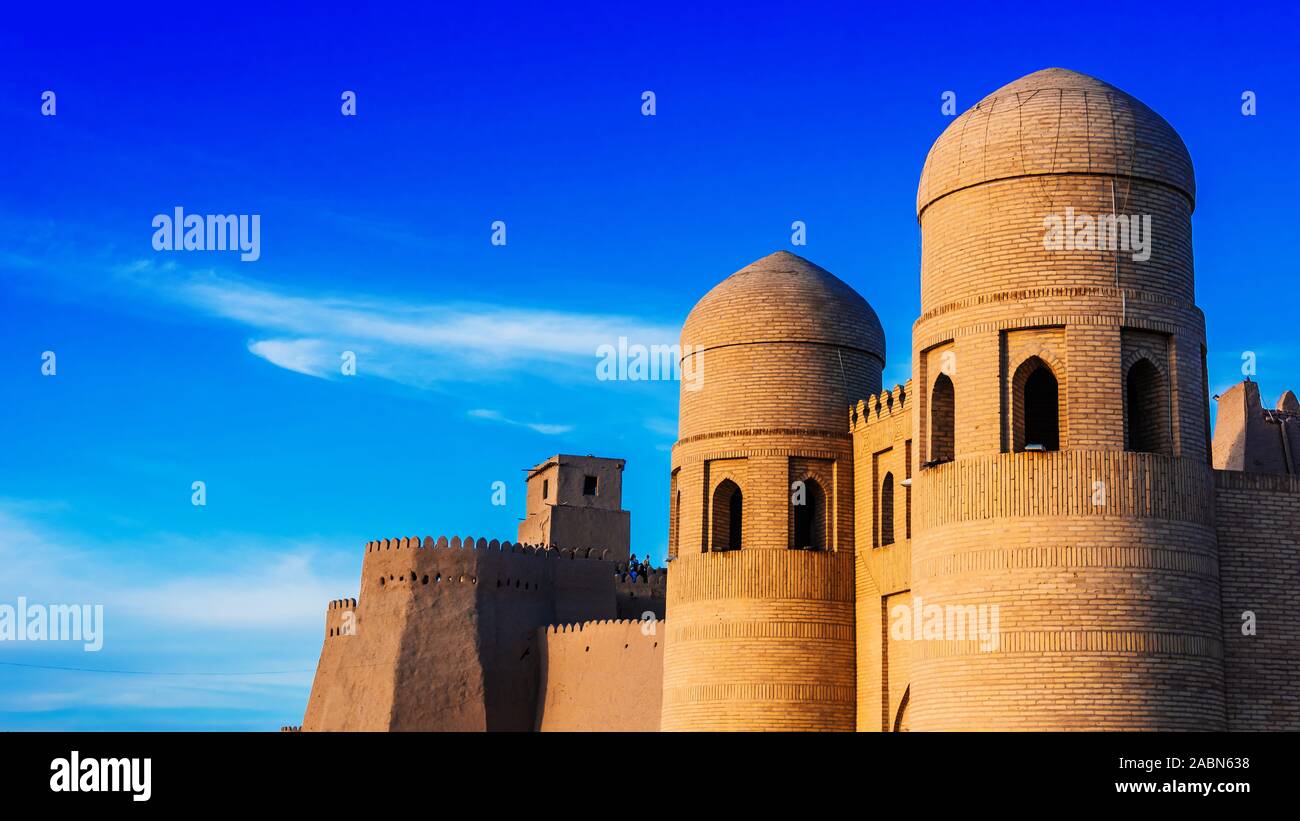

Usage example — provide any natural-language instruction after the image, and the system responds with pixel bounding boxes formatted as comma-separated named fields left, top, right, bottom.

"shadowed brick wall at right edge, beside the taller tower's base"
left=1214, top=470, right=1300, bottom=731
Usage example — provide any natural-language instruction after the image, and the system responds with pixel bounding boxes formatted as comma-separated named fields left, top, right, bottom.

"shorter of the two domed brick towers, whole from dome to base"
left=663, top=251, right=884, bottom=730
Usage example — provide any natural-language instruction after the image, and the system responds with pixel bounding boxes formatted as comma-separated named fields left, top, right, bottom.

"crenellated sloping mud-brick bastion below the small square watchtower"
left=303, top=538, right=616, bottom=731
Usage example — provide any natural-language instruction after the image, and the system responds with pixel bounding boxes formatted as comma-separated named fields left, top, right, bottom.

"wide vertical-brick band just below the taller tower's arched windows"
left=915, top=451, right=1214, bottom=530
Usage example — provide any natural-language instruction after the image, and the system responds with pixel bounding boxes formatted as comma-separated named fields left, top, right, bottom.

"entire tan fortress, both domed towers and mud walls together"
left=302, top=69, right=1300, bottom=731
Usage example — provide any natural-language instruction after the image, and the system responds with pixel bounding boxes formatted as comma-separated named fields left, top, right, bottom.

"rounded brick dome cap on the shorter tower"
left=681, top=251, right=885, bottom=362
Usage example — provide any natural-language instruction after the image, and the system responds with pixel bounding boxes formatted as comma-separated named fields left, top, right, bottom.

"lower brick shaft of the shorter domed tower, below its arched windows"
left=663, top=549, right=855, bottom=730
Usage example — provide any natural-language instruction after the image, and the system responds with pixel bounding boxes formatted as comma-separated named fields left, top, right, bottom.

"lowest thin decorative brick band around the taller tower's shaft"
left=911, top=630, right=1223, bottom=659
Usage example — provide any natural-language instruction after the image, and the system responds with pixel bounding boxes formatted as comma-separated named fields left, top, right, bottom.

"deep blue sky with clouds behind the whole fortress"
left=0, top=3, right=1300, bottom=729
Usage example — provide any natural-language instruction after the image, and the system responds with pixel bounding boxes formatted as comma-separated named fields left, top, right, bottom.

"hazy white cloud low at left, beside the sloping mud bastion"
left=0, top=499, right=360, bottom=729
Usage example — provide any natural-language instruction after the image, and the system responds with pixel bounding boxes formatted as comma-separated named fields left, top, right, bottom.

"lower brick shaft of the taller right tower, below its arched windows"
left=909, top=451, right=1225, bottom=730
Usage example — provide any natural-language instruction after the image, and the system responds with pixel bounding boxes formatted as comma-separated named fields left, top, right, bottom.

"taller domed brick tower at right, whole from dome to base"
left=909, top=69, right=1225, bottom=730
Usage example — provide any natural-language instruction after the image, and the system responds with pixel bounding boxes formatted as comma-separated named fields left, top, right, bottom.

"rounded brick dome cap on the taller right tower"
left=917, top=69, right=1196, bottom=216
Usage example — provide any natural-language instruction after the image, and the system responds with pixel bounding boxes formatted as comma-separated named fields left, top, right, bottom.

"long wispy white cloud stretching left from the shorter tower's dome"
left=126, top=262, right=679, bottom=387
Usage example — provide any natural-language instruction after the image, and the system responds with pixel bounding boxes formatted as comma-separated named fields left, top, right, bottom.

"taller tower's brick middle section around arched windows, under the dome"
left=913, top=175, right=1208, bottom=457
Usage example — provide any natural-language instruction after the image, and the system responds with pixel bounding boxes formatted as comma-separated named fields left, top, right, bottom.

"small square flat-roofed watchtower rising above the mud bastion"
left=519, top=453, right=632, bottom=561
